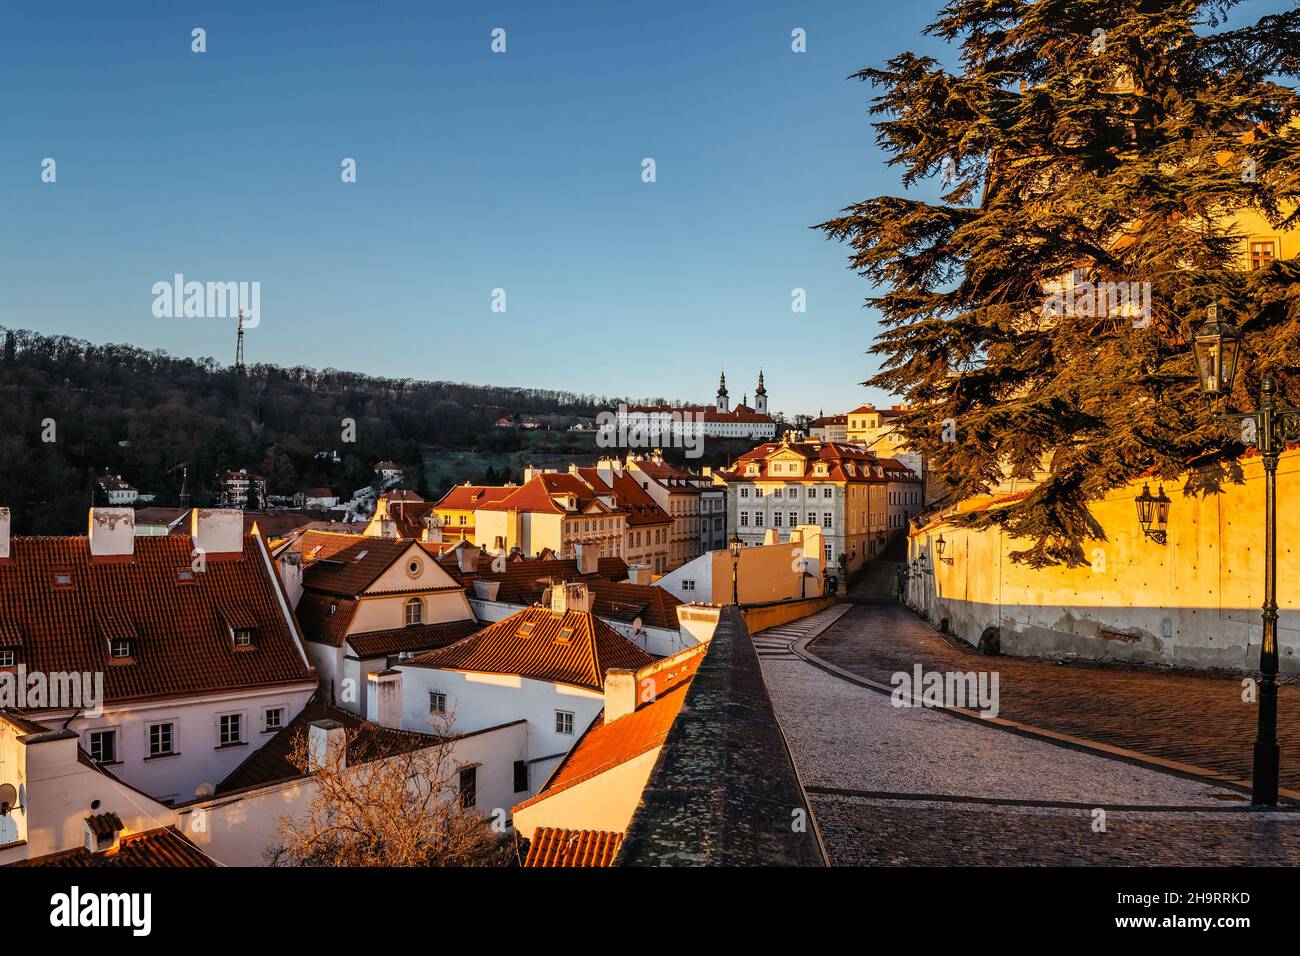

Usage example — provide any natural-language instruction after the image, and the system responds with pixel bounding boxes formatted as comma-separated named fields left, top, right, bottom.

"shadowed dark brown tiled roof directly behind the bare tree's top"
left=216, top=695, right=438, bottom=795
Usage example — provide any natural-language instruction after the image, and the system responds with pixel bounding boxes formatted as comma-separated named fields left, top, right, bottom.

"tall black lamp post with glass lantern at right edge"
left=1192, top=306, right=1300, bottom=806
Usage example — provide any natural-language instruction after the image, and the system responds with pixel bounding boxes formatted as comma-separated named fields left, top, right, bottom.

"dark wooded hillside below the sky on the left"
left=0, top=328, right=662, bottom=533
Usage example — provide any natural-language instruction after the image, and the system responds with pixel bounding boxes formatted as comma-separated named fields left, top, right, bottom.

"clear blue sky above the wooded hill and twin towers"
left=0, top=0, right=1286, bottom=414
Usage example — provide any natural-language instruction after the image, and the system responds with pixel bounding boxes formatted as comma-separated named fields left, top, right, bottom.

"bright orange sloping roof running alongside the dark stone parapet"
left=515, top=644, right=709, bottom=812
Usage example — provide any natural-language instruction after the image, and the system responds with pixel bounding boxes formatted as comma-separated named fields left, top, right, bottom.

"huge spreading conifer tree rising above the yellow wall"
left=818, top=0, right=1300, bottom=566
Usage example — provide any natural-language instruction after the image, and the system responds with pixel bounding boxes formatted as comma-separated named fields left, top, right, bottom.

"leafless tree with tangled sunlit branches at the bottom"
left=265, top=730, right=511, bottom=866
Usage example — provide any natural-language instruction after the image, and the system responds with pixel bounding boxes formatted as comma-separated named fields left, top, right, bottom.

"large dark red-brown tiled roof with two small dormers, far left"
left=0, top=535, right=315, bottom=704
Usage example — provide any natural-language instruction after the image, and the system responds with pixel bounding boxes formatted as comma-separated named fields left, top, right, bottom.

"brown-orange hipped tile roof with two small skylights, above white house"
left=399, top=607, right=655, bottom=691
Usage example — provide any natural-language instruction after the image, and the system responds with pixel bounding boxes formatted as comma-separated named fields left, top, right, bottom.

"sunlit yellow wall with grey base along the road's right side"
left=909, top=451, right=1300, bottom=672
